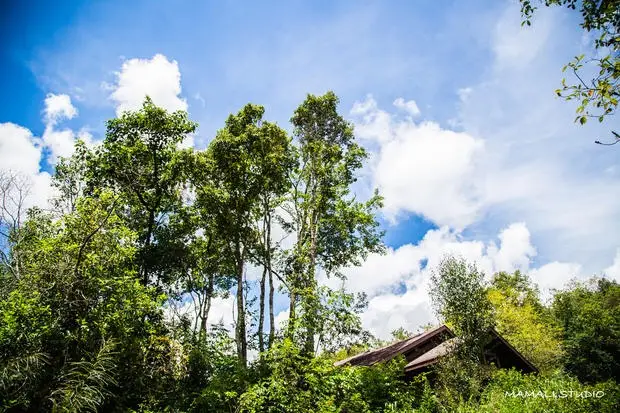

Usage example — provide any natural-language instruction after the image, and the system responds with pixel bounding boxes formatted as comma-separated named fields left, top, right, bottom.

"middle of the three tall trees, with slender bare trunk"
left=197, top=104, right=291, bottom=364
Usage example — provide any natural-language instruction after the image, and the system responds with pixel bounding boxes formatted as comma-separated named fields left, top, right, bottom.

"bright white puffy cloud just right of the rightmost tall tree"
left=351, top=96, right=484, bottom=228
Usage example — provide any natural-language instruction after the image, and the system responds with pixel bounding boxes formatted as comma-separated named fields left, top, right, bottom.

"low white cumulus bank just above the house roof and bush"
left=336, top=223, right=584, bottom=338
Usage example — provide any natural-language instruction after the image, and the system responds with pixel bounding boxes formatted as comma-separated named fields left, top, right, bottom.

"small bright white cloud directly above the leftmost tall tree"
left=110, top=54, right=187, bottom=115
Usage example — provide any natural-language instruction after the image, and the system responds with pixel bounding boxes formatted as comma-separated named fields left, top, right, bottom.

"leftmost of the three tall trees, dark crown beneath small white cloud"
left=88, top=97, right=196, bottom=285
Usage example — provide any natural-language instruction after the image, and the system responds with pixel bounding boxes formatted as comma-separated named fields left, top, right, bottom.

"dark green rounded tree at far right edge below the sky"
left=551, top=279, right=620, bottom=382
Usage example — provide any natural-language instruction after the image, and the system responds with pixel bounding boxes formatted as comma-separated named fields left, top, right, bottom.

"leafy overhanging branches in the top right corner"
left=520, top=0, right=620, bottom=135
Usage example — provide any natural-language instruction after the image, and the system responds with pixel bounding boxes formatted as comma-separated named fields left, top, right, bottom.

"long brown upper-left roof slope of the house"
left=335, top=325, right=454, bottom=366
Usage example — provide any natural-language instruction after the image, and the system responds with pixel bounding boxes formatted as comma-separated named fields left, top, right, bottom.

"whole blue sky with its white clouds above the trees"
left=0, top=0, right=620, bottom=335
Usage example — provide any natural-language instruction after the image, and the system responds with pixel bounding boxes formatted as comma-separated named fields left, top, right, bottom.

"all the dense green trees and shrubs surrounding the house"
left=0, top=93, right=620, bottom=412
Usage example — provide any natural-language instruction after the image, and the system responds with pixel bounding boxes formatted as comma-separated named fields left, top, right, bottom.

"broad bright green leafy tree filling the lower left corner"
left=0, top=192, right=175, bottom=411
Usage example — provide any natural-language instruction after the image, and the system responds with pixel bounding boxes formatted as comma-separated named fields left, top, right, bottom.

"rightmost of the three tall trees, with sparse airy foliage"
left=287, top=92, right=383, bottom=354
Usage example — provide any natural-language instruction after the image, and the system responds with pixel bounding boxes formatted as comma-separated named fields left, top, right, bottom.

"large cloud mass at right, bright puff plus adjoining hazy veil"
left=351, top=6, right=620, bottom=273
